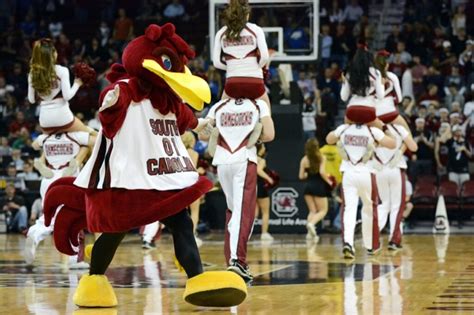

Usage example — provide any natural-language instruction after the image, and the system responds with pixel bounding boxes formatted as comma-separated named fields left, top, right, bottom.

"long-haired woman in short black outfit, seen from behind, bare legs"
left=298, top=138, right=333, bottom=242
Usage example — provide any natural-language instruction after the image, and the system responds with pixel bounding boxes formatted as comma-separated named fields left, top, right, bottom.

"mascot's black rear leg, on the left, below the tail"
left=89, top=233, right=126, bottom=275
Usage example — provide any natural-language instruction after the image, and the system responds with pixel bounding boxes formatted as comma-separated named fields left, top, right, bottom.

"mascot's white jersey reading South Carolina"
left=74, top=92, right=198, bottom=191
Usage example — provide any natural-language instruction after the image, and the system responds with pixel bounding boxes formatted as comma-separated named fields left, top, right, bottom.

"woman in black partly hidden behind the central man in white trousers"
left=255, top=143, right=275, bottom=241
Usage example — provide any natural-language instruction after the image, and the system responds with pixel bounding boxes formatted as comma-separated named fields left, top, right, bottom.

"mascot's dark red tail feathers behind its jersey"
left=44, top=177, right=87, bottom=255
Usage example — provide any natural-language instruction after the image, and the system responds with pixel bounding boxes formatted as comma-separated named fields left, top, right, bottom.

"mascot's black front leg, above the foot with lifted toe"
left=162, top=211, right=203, bottom=278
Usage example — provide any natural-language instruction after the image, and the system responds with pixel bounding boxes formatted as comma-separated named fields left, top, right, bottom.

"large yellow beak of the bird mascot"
left=142, top=59, right=211, bottom=110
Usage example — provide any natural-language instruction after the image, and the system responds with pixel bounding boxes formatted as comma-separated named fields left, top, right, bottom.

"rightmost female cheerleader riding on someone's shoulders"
left=374, top=50, right=410, bottom=131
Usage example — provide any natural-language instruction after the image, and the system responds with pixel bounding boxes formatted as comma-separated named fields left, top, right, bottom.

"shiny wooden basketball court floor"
left=0, top=235, right=474, bottom=315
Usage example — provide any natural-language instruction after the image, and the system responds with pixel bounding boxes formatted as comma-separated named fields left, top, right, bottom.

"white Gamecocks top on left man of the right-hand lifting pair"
left=334, top=124, right=385, bottom=173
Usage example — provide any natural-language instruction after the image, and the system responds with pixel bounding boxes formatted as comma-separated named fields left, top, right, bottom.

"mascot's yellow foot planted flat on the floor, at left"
left=73, top=275, right=117, bottom=307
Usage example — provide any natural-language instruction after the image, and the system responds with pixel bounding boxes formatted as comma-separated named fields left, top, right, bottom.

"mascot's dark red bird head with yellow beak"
left=116, top=23, right=211, bottom=110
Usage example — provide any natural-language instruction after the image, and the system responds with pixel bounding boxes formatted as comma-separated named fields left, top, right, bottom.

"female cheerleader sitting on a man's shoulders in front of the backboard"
left=212, top=0, right=270, bottom=105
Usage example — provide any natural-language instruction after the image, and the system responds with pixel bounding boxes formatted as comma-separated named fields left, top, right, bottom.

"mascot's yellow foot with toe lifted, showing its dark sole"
left=183, top=271, right=247, bottom=307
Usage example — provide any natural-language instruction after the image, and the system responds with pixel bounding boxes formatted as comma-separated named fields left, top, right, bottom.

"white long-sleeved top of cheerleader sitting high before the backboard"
left=212, top=23, right=269, bottom=79
